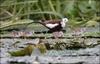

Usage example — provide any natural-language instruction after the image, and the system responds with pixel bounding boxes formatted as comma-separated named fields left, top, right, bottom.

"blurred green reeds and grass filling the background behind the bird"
left=0, top=0, right=100, bottom=29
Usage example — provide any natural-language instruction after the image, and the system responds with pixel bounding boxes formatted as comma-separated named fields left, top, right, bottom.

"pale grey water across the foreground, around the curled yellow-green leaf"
left=0, top=39, right=100, bottom=64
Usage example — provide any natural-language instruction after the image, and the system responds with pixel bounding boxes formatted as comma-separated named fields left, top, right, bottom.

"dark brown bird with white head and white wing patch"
left=38, top=18, right=68, bottom=39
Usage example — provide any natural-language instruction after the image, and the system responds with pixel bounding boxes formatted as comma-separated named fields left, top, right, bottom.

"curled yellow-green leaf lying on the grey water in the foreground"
left=8, top=41, right=47, bottom=57
